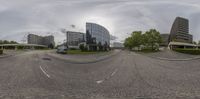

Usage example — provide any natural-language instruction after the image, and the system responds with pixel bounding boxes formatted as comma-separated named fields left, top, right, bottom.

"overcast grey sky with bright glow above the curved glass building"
left=0, top=0, right=200, bottom=44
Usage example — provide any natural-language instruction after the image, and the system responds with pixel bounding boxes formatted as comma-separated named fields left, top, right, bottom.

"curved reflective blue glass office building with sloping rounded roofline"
left=86, top=23, right=110, bottom=50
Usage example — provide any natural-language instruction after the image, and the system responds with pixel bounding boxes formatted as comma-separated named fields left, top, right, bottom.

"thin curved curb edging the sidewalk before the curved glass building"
left=46, top=51, right=121, bottom=64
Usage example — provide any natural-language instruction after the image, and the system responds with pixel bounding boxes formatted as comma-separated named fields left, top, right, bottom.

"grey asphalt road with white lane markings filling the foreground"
left=0, top=51, right=200, bottom=99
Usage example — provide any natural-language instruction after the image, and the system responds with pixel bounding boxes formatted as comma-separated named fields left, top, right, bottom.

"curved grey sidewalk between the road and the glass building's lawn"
left=47, top=50, right=120, bottom=64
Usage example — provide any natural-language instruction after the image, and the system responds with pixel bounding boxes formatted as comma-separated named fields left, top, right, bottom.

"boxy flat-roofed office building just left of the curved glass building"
left=67, top=31, right=86, bottom=47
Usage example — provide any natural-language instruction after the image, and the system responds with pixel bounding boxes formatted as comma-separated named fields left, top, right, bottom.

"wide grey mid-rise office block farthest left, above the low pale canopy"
left=28, top=34, right=55, bottom=48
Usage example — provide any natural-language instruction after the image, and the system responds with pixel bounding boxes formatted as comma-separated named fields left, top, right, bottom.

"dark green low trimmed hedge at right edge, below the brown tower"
left=173, top=48, right=200, bottom=55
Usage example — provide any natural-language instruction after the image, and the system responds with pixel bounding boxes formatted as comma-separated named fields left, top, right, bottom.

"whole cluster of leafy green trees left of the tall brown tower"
left=124, top=29, right=162, bottom=50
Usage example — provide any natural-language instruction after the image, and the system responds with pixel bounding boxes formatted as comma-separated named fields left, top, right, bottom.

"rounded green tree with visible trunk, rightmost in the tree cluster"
left=144, top=29, right=162, bottom=50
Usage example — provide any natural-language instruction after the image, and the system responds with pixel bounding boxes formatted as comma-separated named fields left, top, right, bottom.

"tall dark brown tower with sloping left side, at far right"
left=169, top=17, right=193, bottom=43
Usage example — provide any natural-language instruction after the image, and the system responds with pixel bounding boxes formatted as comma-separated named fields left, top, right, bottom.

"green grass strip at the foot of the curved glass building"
left=67, top=50, right=109, bottom=55
